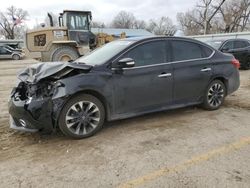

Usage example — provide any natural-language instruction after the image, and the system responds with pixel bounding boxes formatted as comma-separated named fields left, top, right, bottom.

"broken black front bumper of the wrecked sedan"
left=9, top=94, right=54, bottom=132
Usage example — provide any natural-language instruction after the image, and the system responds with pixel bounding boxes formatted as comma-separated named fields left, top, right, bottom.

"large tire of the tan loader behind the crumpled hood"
left=52, top=46, right=79, bottom=62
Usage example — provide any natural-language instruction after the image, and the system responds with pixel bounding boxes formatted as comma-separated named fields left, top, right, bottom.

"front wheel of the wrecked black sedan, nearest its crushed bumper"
left=58, top=94, right=105, bottom=139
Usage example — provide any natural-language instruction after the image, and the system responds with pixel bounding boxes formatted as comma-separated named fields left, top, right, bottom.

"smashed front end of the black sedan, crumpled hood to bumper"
left=9, top=62, right=91, bottom=132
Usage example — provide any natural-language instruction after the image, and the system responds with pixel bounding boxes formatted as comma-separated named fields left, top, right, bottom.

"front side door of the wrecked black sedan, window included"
left=113, top=40, right=173, bottom=114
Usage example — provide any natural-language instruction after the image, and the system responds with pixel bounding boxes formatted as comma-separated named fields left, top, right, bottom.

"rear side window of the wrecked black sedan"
left=171, top=40, right=204, bottom=61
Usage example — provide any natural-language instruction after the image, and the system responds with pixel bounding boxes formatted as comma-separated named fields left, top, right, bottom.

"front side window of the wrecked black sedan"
left=123, top=41, right=166, bottom=67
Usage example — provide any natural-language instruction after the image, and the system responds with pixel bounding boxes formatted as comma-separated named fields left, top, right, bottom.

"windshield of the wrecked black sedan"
left=75, top=40, right=133, bottom=66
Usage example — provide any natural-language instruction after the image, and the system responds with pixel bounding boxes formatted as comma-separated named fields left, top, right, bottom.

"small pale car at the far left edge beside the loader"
left=0, top=45, right=24, bottom=60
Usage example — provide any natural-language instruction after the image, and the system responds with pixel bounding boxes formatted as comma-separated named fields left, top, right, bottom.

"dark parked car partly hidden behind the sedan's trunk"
left=206, top=39, right=250, bottom=70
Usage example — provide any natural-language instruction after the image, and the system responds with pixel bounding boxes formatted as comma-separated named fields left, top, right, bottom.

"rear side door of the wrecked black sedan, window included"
left=171, top=39, right=214, bottom=105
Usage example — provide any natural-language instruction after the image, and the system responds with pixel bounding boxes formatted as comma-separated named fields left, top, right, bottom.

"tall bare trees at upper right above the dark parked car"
left=177, top=0, right=250, bottom=35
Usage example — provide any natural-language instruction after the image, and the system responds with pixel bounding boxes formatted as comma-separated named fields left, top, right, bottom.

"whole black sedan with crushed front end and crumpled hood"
left=9, top=37, right=240, bottom=138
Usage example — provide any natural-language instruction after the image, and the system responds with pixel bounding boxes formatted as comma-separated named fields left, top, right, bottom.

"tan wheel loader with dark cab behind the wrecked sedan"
left=26, top=10, right=126, bottom=61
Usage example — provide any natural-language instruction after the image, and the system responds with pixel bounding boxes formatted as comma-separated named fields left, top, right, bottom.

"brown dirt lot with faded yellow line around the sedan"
left=0, top=60, right=250, bottom=188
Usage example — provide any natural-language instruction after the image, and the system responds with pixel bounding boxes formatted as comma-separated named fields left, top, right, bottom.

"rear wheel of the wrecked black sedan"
left=203, top=80, right=226, bottom=110
